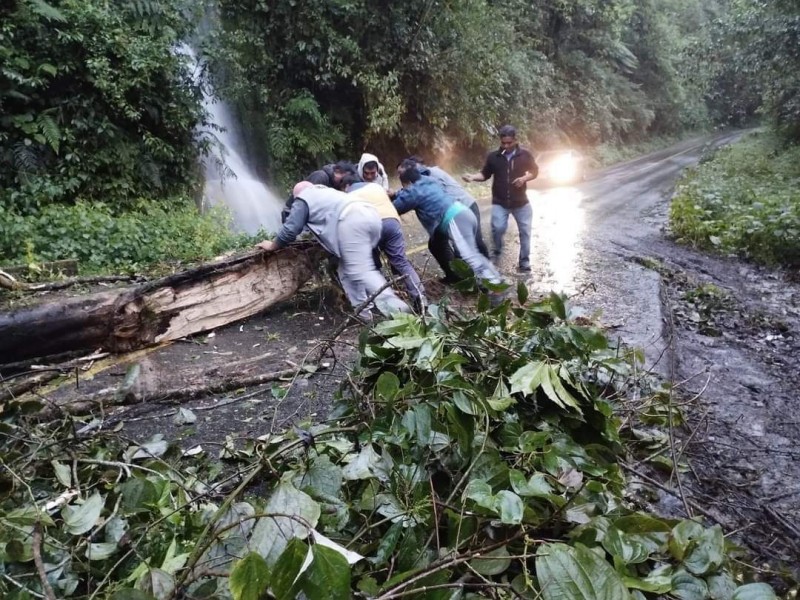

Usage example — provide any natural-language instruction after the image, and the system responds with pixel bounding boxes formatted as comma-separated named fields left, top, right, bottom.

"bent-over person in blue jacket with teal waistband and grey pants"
left=392, top=166, right=502, bottom=284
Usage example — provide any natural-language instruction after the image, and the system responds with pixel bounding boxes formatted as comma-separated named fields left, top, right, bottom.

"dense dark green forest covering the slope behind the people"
left=0, top=0, right=800, bottom=268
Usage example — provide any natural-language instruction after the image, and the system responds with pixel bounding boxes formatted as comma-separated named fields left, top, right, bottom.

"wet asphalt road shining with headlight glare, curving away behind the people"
left=403, top=133, right=740, bottom=374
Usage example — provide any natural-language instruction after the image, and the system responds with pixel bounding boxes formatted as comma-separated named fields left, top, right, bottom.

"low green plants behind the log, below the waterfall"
left=0, top=198, right=260, bottom=278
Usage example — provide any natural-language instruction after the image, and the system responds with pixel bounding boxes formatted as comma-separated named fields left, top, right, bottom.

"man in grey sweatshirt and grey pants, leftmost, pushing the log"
left=258, top=181, right=411, bottom=321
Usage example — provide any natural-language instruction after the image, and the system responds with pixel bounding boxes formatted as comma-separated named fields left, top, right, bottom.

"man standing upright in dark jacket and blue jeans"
left=463, top=125, right=539, bottom=272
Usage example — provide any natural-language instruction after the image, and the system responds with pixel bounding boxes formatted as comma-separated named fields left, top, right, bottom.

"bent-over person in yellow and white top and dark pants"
left=342, top=175, right=428, bottom=312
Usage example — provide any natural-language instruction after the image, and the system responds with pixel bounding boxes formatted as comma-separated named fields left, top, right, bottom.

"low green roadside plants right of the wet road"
left=670, top=133, right=800, bottom=269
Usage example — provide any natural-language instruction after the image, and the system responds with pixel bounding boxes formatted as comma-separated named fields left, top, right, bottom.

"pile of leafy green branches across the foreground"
left=0, top=287, right=775, bottom=600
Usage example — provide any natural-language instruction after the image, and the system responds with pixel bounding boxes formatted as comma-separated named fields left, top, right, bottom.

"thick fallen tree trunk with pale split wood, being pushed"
left=0, top=243, right=322, bottom=365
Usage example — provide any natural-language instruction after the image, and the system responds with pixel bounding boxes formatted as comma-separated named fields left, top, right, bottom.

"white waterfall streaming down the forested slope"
left=179, top=45, right=283, bottom=234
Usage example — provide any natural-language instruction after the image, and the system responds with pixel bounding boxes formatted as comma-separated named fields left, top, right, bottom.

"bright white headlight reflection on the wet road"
left=528, top=187, right=586, bottom=294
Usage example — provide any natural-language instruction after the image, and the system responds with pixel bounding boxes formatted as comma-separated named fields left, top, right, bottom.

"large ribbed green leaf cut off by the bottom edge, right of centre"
left=536, top=544, right=630, bottom=600
